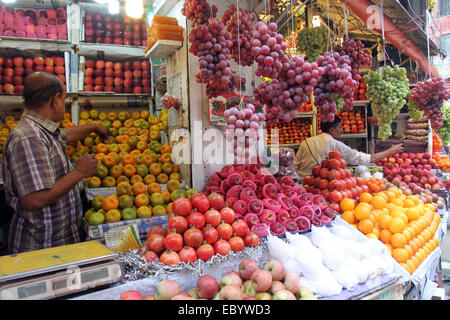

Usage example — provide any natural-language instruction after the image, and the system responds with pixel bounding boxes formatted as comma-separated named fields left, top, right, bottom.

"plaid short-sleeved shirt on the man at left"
left=2, top=109, right=82, bottom=254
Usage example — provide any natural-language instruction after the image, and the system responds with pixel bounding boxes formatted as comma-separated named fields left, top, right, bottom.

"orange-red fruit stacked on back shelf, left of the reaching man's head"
left=266, top=118, right=311, bottom=145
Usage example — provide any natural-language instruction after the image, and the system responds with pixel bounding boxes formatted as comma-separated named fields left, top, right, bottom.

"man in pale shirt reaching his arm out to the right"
left=294, top=117, right=403, bottom=180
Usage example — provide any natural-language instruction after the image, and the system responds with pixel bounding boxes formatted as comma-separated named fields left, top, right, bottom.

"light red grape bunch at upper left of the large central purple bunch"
left=252, top=21, right=289, bottom=79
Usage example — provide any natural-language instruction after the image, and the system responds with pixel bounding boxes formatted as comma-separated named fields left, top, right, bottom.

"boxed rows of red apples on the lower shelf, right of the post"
left=83, top=59, right=151, bottom=94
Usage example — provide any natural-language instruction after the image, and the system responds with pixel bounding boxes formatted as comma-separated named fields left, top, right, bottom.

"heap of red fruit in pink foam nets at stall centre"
left=206, top=164, right=335, bottom=236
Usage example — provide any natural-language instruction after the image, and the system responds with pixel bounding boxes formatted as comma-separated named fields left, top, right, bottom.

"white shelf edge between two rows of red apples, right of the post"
left=78, top=43, right=145, bottom=59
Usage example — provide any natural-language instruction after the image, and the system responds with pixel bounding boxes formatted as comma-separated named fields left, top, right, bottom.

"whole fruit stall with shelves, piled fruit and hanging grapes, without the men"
left=0, top=0, right=450, bottom=301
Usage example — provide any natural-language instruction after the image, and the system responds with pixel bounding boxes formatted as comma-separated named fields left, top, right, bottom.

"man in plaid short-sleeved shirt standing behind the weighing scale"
left=2, top=72, right=108, bottom=254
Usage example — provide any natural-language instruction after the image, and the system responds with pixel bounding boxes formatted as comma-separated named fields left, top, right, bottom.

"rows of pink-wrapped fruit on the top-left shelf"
left=0, top=6, right=67, bottom=40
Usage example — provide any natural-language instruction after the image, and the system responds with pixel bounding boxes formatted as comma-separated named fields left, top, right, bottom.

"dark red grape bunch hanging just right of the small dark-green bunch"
left=333, top=39, right=372, bottom=85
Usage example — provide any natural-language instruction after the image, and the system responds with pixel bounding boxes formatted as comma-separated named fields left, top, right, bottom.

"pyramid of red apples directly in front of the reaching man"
left=303, top=150, right=369, bottom=212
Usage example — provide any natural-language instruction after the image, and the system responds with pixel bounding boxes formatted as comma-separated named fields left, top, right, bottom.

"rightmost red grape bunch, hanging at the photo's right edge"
left=411, top=78, right=450, bottom=129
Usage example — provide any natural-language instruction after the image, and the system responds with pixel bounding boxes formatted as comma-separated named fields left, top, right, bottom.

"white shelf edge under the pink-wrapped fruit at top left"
left=0, top=36, right=71, bottom=52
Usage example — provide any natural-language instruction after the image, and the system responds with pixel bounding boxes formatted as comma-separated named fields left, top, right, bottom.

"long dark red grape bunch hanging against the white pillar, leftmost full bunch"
left=189, top=18, right=234, bottom=98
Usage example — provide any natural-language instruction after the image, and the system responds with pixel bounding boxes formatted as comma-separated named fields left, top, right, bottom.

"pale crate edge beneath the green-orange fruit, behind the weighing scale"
left=83, top=214, right=169, bottom=240
